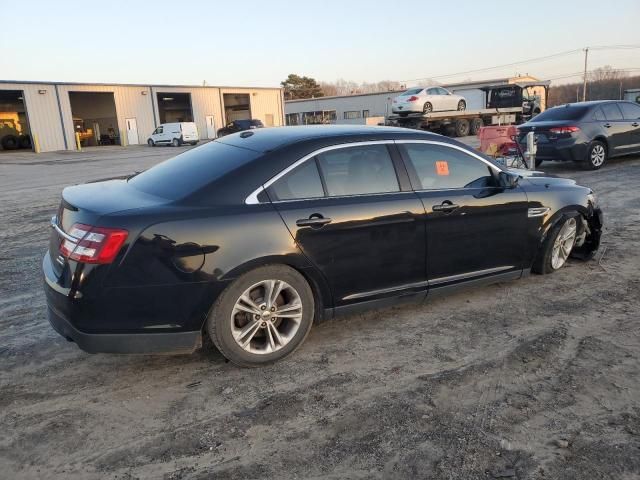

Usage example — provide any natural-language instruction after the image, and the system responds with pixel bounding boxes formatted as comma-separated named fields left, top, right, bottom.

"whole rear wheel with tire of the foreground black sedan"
left=206, top=265, right=315, bottom=367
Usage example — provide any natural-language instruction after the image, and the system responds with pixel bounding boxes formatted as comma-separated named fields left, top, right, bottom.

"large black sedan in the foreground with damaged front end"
left=43, top=126, right=602, bottom=366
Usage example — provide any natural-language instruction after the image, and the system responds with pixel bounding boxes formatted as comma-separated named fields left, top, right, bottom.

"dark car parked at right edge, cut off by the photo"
left=518, top=100, right=640, bottom=170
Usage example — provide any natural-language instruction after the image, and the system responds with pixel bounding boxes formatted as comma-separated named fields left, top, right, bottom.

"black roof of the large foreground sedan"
left=215, top=125, right=444, bottom=152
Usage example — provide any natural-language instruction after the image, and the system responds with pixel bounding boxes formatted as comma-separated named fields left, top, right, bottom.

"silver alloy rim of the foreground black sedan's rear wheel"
left=231, top=280, right=302, bottom=354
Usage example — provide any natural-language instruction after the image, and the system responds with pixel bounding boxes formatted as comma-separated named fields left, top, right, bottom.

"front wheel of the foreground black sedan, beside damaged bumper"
left=531, top=214, right=578, bottom=275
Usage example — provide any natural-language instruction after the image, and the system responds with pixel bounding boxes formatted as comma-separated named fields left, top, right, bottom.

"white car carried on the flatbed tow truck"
left=391, top=87, right=467, bottom=114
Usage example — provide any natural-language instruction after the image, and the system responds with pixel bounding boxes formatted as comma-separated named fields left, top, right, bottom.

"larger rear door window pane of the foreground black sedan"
left=317, top=145, right=400, bottom=197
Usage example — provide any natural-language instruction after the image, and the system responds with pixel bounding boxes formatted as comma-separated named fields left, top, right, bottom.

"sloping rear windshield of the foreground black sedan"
left=129, top=141, right=261, bottom=200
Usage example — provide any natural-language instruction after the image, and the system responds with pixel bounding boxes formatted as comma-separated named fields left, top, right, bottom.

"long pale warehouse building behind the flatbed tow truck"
left=285, top=76, right=544, bottom=125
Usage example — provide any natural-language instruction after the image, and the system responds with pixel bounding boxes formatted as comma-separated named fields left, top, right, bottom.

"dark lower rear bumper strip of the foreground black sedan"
left=47, top=306, right=202, bottom=354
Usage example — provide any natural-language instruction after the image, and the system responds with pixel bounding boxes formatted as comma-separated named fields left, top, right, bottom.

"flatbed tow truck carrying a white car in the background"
left=386, top=81, right=549, bottom=137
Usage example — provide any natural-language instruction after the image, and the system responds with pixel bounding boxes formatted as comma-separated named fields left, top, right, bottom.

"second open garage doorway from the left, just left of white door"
left=69, top=92, right=121, bottom=147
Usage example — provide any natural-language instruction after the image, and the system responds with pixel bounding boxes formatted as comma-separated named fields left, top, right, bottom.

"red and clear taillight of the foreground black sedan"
left=60, top=223, right=129, bottom=263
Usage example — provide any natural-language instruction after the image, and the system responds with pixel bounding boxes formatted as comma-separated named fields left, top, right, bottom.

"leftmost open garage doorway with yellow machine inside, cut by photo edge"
left=0, top=90, right=32, bottom=152
